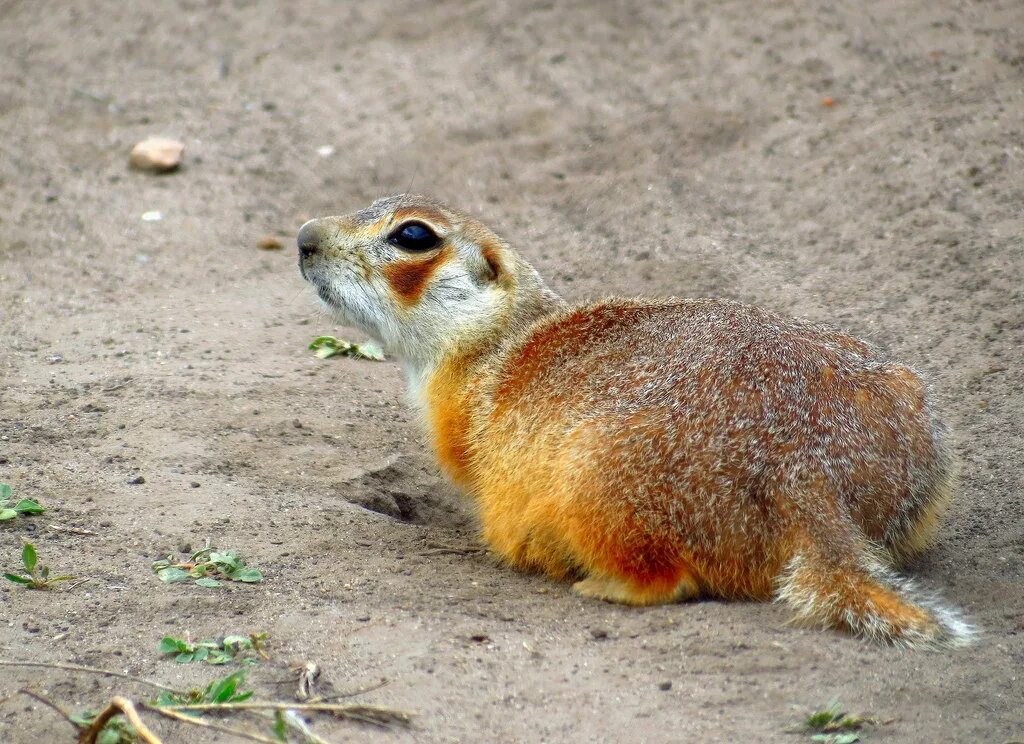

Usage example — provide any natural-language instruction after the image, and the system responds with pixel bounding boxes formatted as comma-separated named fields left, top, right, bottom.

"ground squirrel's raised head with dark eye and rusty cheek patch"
left=298, top=194, right=560, bottom=366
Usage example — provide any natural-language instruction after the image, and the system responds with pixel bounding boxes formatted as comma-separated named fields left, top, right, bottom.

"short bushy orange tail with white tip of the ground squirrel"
left=776, top=546, right=976, bottom=648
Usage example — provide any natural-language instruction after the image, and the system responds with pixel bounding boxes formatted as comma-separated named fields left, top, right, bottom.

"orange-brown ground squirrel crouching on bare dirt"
left=298, top=194, right=972, bottom=646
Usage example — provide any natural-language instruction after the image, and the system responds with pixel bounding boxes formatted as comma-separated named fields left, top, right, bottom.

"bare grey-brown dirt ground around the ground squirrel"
left=0, top=0, right=1024, bottom=742
